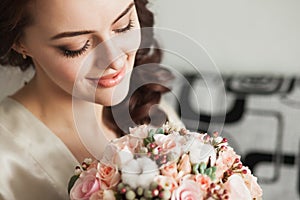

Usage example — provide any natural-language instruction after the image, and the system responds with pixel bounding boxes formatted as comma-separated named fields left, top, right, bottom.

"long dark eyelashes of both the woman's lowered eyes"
left=61, top=20, right=134, bottom=58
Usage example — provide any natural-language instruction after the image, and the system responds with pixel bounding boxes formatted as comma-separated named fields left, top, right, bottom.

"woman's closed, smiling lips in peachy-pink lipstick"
left=88, top=66, right=126, bottom=88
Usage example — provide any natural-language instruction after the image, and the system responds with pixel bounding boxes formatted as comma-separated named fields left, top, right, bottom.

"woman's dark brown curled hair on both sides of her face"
left=0, top=0, right=172, bottom=136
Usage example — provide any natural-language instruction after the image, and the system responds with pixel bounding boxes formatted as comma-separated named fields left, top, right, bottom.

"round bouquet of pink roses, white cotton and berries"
left=69, top=123, right=262, bottom=200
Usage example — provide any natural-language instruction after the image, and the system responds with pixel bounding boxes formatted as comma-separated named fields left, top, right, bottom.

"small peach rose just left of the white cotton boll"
left=99, top=163, right=121, bottom=190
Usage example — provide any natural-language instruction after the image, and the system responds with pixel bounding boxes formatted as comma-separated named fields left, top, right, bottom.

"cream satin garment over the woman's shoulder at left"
left=0, top=98, right=78, bottom=200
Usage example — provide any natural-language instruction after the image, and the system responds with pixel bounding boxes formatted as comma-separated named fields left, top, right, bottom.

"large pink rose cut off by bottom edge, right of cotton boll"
left=171, top=180, right=204, bottom=200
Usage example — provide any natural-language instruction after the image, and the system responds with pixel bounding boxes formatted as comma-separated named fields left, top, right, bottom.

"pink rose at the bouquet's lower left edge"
left=70, top=168, right=100, bottom=200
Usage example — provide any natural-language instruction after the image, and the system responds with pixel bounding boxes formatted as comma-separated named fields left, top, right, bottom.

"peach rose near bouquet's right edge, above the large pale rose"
left=216, top=147, right=240, bottom=179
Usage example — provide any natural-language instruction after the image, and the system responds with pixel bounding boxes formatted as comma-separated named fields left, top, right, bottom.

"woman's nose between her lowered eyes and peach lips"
left=94, top=40, right=127, bottom=71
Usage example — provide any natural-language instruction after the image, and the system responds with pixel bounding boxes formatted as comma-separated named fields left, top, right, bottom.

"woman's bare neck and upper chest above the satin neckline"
left=12, top=72, right=116, bottom=160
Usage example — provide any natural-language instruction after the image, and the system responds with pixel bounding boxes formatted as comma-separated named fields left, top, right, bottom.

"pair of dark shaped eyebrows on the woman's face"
left=50, top=2, right=134, bottom=40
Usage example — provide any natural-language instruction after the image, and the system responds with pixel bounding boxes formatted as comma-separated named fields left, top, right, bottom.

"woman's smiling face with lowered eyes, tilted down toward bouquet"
left=20, top=0, right=141, bottom=105
